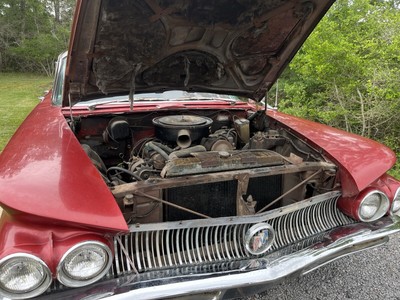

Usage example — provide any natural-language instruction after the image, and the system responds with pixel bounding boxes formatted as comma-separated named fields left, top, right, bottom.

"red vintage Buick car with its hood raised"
left=0, top=0, right=400, bottom=299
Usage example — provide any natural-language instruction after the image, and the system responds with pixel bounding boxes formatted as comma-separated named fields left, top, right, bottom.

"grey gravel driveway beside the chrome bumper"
left=243, top=234, right=400, bottom=300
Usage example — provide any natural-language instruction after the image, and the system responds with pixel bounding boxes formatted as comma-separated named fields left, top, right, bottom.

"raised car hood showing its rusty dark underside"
left=63, top=0, right=334, bottom=106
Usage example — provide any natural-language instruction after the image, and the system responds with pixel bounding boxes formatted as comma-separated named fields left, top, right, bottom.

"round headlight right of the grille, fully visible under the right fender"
left=358, top=191, right=390, bottom=222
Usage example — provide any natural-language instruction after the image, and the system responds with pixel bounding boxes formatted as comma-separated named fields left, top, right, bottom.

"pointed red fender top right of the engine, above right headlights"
left=269, top=111, right=396, bottom=197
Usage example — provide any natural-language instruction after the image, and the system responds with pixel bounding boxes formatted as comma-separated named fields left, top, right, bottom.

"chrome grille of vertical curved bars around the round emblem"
left=113, top=192, right=354, bottom=275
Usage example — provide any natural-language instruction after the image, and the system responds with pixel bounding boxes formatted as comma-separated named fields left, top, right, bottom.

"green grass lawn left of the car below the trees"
left=0, top=73, right=53, bottom=152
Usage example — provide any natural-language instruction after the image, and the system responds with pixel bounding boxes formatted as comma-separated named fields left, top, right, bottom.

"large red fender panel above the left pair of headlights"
left=0, top=98, right=127, bottom=231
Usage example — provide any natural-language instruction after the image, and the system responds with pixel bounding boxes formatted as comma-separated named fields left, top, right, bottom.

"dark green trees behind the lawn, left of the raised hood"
left=0, top=0, right=74, bottom=75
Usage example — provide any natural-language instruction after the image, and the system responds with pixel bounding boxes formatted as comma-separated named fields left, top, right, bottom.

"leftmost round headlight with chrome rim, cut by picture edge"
left=0, top=253, right=52, bottom=299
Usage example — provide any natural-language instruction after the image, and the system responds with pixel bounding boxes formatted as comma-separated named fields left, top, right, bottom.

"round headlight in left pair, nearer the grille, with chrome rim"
left=57, top=241, right=112, bottom=287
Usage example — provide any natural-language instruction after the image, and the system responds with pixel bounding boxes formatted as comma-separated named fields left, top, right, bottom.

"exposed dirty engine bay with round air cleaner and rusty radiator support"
left=74, top=109, right=337, bottom=224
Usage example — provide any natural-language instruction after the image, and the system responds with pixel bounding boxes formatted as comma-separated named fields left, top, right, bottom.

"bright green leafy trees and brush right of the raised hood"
left=280, top=0, right=400, bottom=177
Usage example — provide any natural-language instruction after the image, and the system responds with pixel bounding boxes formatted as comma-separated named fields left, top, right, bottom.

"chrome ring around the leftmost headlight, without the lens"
left=0, top=253, right=53, bottom=299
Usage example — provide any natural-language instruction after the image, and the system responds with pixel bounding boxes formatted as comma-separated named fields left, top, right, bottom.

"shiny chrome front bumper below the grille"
left=41, top=217, right=400, bottom=299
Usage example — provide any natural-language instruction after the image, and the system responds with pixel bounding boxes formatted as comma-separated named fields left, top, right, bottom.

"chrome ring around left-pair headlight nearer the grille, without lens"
left=57, top=241, right=112, bottom=287
